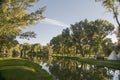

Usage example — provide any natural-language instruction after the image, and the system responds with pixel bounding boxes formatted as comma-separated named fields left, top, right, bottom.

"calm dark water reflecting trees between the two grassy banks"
left=39, top=57, right=120, bottom=80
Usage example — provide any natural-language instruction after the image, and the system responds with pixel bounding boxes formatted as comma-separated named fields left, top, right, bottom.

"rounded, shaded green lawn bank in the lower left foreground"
left=0, top=58, right=52, bottom=80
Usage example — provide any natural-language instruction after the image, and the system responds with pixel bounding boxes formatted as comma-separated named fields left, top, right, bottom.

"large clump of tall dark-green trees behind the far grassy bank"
left=50, top=19, right=114, bottom=57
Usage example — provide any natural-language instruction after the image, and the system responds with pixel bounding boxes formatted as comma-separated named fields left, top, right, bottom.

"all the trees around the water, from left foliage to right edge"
left=0, top=0, right=120, bottom=57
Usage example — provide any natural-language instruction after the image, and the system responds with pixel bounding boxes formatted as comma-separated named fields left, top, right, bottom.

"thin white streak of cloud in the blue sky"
left=43, top=18, right=69, bottom=27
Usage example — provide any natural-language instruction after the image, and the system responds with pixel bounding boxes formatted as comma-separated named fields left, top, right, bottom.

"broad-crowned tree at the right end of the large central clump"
left=88, top=20, right=114, bottom=54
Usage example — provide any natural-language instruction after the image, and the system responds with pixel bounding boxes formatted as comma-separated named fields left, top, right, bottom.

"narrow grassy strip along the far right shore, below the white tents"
left=54, top=56, right=120, bottom=70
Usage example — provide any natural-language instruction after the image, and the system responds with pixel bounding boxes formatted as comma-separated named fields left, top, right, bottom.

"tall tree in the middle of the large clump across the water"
left=70, top=20, right=88, bottom=57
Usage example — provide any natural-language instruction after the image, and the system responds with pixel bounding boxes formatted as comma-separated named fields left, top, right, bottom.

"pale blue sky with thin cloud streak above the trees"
left=18, top=0, right=116, bottom=45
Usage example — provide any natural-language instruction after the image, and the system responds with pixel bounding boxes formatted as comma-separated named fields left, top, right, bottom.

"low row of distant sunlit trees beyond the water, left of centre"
left=11, top=43, right=50, bottom=59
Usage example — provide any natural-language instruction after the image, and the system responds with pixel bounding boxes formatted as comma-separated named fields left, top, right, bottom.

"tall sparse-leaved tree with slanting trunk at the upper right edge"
left=95, top=0, right=120, bottom=51
